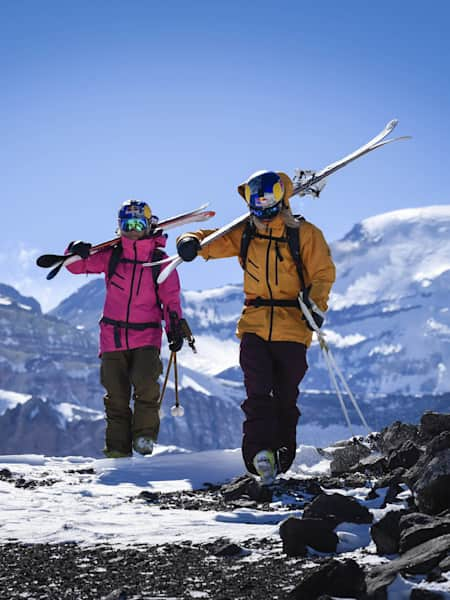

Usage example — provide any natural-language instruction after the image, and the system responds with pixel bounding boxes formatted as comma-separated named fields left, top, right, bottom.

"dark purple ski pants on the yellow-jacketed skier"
left=240, top=333, right=308, bottom=473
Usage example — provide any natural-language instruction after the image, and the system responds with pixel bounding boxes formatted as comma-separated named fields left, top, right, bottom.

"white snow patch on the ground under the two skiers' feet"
left=0, top=446, right=334, bottom=546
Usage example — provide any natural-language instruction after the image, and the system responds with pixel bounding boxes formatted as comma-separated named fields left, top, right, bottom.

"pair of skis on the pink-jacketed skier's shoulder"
left=36, top=204, right=216, bottom=279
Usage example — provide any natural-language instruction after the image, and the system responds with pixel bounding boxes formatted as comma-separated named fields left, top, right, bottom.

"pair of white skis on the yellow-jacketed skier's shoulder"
left=156, top=119, right=411, bottom=283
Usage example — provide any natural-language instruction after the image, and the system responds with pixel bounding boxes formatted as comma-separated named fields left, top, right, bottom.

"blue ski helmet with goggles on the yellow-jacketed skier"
left=244, top=171, right=284, bottom=220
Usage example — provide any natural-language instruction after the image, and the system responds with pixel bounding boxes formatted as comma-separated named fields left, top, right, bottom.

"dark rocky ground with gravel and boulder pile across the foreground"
left=0, top=413, right=450, bottom=600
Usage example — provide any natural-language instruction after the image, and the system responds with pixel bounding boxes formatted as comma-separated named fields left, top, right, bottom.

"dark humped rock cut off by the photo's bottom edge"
left=288, top=559, right=365, bottom=600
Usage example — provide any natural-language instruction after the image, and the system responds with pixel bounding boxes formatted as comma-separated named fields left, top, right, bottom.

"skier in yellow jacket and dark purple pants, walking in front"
left=177, top=171, right=335, bottom=483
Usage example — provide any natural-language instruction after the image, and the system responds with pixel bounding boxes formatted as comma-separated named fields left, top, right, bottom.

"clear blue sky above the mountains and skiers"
left=0, top=0, right=450, bottom=309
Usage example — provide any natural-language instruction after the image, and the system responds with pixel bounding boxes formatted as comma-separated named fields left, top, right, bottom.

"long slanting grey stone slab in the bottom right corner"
left=366, top=535, right=450, bottom=600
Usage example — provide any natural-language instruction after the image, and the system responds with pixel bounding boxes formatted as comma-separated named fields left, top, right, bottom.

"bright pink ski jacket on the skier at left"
left=67, top=235, right=182, bottom=356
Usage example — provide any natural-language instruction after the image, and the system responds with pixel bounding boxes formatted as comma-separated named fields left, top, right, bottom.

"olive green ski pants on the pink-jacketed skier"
left=100, top=346, right=162, bottom=454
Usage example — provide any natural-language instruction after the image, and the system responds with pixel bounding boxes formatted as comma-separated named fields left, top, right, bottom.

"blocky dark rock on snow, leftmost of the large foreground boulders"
left=280, top=517, right=339, bottom=556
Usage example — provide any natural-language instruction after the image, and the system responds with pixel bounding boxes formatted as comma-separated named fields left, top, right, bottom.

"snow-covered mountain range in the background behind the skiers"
left=0, top=206, right=450, bottom=450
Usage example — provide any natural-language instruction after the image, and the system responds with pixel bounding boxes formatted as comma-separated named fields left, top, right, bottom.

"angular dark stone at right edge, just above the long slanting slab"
left=399, top=513, right=450, bottom=554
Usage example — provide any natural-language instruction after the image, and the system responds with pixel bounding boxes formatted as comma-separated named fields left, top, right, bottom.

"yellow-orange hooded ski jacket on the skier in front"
left=179, top=174, right=335, bottom=346
